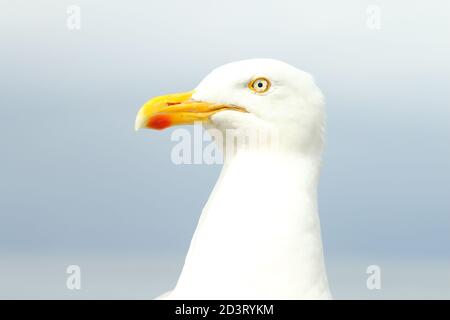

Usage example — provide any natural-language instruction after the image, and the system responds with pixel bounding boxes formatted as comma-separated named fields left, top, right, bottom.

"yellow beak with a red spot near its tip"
left=135, top=91, right=247, bottom=130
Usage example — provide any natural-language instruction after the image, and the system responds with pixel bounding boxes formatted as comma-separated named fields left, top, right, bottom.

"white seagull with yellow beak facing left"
left=135, top=59, right=331, bottom=300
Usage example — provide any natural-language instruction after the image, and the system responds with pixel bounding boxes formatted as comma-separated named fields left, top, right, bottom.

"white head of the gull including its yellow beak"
left=135, top=59, right=324, bottom=155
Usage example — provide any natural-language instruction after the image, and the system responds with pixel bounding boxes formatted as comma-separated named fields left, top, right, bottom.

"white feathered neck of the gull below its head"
left=174, top=151, right=329, bottom=299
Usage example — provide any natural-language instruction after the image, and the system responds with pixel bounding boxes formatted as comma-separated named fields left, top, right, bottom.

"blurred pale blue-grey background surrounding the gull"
left=0, top=0, right=450, bottom=299
